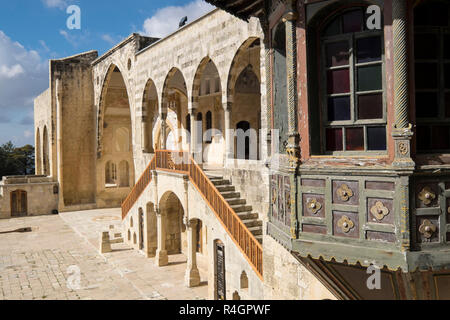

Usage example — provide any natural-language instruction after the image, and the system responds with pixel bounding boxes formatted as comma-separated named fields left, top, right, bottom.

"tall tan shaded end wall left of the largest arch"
left=51, top=52, right=97, bottom=209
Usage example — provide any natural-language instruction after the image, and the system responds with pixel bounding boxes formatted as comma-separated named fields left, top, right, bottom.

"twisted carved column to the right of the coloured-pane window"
left=392, top=0, right=415, bottom=168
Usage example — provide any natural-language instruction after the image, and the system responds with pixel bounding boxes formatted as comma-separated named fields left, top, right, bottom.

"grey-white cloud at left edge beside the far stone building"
left=0, top=30, right=48, bottom=129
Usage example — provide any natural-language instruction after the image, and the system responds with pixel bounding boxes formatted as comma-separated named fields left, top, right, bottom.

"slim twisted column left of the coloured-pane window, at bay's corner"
left=283, top=0, right=300, bottom=171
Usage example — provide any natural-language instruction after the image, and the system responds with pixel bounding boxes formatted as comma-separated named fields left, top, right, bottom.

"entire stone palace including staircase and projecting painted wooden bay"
left=0, top=0, right=450, bottom=300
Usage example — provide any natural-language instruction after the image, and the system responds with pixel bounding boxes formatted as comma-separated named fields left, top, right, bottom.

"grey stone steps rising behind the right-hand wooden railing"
left=206, top=173, right=263, bottom=244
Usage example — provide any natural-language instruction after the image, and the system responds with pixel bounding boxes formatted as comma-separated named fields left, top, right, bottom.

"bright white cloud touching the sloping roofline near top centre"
left=141, top=0, right=214, bottom=38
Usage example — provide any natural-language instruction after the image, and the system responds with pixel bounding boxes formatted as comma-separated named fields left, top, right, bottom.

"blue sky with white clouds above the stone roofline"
left=0, top=0, right=212, bottom=146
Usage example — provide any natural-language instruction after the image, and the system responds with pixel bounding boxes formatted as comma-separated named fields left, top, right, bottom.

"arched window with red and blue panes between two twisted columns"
left=310, top=6, right=387, bottom=154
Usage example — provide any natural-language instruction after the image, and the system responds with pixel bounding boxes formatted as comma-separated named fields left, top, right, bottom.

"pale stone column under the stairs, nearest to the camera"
left=185, top=220, right=200, bottom=288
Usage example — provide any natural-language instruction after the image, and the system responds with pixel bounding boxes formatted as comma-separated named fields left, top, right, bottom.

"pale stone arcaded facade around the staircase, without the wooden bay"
left=22, top=10, right=342, bottom=299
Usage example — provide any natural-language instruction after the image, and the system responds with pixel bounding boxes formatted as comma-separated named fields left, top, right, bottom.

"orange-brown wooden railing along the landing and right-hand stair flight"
left=156, top=150, right=263, bottom=278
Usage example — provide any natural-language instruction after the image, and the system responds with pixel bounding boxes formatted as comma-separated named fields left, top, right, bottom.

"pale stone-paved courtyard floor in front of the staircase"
left=0, top=209, right=208, bottom=300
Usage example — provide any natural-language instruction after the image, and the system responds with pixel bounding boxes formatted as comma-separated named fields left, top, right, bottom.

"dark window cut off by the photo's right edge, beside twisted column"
left=414, top=1, right=450, bottom=153
